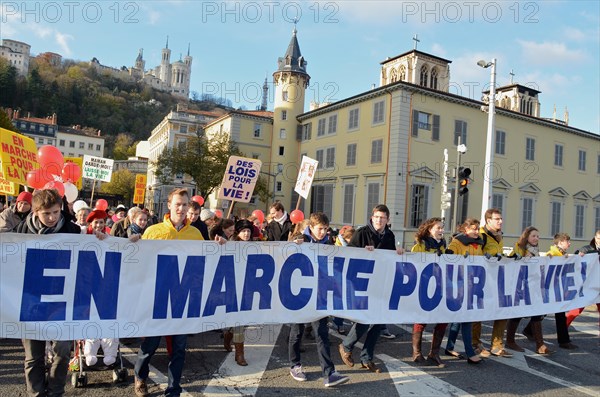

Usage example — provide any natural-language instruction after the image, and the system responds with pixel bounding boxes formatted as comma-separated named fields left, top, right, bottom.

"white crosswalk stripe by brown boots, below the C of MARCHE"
left=203, top=324, right=281, bottom=397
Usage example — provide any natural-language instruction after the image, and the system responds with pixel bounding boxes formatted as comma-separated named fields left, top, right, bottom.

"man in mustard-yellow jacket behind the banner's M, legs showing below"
left=134, top=189, right=204, bottom=397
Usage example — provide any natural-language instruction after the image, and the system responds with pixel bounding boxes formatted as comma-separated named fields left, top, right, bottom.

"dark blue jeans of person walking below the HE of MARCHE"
left=288, top=317, right=335, bottom=378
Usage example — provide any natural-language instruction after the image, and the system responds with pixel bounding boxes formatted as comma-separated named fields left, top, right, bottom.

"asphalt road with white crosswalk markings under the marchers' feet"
left=0, top=305, right=600, bottom=397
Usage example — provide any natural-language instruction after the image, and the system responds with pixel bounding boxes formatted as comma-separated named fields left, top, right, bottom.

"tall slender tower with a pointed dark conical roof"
left=272, top=28, right=310, bottom=207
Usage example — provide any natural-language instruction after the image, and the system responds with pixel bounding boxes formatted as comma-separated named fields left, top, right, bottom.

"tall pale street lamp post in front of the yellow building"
left=477, top=58, right=496, bottom=221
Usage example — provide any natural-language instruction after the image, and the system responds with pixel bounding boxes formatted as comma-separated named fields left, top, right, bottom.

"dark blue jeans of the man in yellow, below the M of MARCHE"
left=134, top=335, right=187, bottom=397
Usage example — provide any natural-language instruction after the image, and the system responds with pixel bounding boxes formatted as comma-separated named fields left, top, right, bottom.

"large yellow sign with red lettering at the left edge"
left=0, top=128, right=40, bottom=185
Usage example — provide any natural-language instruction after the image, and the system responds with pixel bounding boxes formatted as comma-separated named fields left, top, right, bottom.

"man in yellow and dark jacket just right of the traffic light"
left=473, top=208, right=512, bottom=357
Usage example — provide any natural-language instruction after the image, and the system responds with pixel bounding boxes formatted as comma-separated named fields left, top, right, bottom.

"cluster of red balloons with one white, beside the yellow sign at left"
left=26, top=145, right=81, bottom=203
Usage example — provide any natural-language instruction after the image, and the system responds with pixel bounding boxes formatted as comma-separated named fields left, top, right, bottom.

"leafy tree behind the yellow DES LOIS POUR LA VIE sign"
left=153, top=132, right=266, bottom=200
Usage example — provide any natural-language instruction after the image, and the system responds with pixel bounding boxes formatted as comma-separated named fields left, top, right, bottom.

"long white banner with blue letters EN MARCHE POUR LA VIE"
left=0, top=233, right=600, bottom=340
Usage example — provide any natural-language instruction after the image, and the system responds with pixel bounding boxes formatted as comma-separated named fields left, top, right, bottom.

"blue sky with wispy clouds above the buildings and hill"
left=0, top=0, right=600, bottom=133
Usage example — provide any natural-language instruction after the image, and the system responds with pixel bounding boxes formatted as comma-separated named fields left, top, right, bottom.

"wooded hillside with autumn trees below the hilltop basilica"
left=0, top=58, right=226, bottom=153
